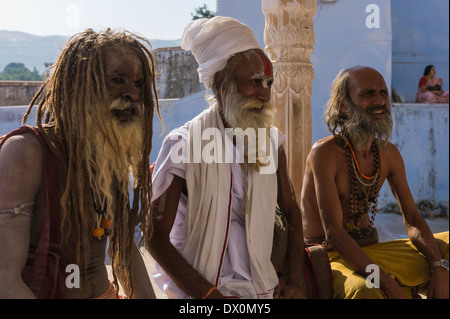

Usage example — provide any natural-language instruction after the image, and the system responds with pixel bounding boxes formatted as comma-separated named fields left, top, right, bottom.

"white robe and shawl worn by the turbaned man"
left=153, top=109, right=284, bottom=299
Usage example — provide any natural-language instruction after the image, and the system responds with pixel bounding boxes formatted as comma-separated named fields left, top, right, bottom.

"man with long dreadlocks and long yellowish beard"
left=0, top=29, right=159, bottom=298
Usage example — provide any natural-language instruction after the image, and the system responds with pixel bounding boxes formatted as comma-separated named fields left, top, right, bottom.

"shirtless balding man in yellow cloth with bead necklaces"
left=301, top=67, right=449, bottom=299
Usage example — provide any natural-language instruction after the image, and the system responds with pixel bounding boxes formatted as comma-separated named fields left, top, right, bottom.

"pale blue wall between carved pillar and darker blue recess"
left=311, top=0, right=392, bottom=143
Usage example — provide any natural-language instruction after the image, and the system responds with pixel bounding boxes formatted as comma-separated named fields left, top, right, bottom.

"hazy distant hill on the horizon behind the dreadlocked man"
left=0, top=30, right=180, bottom=74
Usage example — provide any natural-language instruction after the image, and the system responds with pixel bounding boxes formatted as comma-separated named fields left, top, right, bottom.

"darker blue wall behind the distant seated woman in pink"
left=391, top=0, right=449, bottom=102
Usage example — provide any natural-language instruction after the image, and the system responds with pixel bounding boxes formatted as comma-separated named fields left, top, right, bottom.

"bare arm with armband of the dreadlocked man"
left=0, top=134, right=44, bottom=299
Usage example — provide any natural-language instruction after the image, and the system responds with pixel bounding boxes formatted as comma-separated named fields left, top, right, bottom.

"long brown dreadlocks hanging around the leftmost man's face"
left=22, top=29, right=162, bottom=297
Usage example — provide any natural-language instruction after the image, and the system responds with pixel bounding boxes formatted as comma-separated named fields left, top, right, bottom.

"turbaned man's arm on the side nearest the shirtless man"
left=274, top=147, right=305, bottom=299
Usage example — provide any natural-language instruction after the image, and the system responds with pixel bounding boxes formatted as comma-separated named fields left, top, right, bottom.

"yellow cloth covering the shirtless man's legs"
left=328, top=231, right=449, bottom=299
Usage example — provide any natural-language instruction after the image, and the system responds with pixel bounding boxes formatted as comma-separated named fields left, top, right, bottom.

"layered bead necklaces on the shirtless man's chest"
left=342, top=136, right=381, bottom=239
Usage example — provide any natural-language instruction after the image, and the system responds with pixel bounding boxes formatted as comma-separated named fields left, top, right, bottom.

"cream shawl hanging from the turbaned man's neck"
left=181, top=109, right=278, bottom=298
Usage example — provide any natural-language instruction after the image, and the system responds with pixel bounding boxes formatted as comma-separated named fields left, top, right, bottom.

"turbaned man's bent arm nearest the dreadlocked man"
left=148, top=176, right=223, bottom=299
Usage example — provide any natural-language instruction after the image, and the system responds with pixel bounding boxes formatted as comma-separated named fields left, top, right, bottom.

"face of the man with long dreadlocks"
left=105, top=46, right=145, bottom=123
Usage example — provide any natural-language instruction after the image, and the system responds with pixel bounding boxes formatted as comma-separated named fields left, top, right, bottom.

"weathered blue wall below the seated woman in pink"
left=379, top=103, right=449, bottom=207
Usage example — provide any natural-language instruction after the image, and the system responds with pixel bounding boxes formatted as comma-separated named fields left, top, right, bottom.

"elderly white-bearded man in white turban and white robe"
left=147, top=17, right=304, bottom=299
